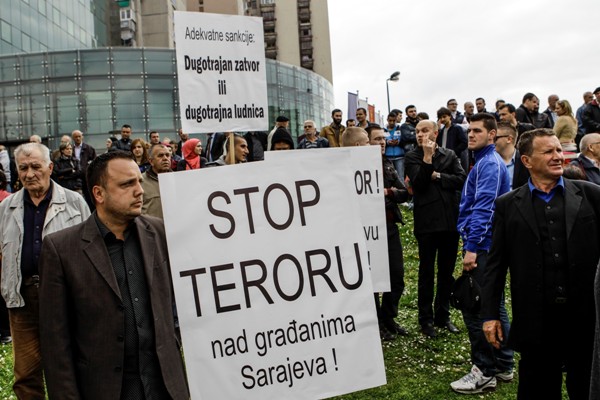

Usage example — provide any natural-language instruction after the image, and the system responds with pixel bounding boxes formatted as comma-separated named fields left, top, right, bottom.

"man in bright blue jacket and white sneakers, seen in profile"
left=450, top=113, right=514, bottom=394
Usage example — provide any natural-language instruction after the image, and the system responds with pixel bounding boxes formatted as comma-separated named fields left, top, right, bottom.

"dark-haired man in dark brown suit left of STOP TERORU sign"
left=40, top=151, right=189, bottom=399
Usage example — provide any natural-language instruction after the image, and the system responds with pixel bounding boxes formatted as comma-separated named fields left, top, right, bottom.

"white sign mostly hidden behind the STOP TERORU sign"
left=265, top=146, right=390, bottom=293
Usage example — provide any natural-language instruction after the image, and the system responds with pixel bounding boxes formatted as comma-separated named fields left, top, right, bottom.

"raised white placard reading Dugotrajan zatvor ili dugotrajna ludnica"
left=175, top=11, right=269, bottom=133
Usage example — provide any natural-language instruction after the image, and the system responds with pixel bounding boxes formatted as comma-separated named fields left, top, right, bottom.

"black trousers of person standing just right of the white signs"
left=375, top=224, right=404, bottom=325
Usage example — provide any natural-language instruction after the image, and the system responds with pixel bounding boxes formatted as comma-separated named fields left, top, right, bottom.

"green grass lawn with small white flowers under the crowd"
left=0, top=209, right=524, bottom=400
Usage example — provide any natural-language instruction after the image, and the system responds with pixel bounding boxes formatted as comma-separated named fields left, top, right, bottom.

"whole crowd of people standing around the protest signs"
left=0, top=87, right=600, bottom=400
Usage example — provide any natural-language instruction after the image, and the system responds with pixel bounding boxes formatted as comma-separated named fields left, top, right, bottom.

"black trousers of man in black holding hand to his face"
left=416, top=232, right=458, bottom=326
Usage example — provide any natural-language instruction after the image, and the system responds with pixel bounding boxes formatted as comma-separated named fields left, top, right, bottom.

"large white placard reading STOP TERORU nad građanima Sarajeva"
left=159, top=153, right=385, bottom=399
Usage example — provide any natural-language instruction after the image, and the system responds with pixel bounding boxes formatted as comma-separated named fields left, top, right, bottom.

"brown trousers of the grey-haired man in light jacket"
left=8, top=283, right=45, bottom=400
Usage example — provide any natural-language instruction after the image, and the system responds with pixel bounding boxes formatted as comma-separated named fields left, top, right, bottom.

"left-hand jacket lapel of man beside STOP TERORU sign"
left=81, top=216, right=121, bottom=299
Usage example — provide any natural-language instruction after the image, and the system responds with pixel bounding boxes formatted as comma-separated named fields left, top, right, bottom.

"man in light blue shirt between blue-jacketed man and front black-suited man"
left=494, top=121, right=529, bottom=190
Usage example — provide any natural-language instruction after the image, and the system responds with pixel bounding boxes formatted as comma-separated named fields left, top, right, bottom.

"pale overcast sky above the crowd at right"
left=328, top=0, right=600, bottom=120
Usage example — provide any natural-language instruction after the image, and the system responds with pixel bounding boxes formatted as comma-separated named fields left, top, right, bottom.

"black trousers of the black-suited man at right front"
left=517, top=304, right=594, bottom=400
